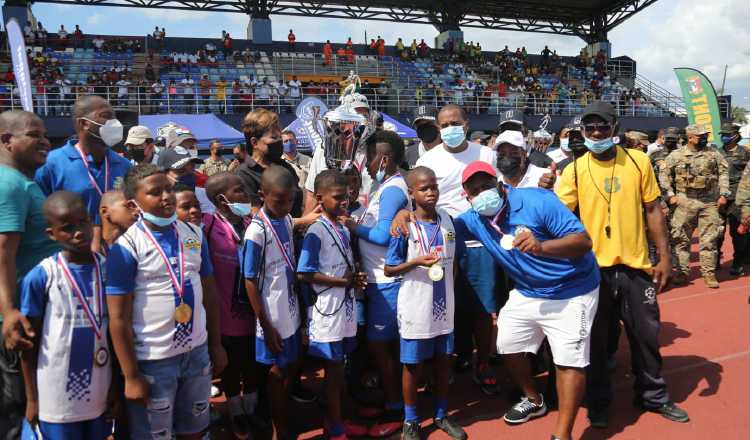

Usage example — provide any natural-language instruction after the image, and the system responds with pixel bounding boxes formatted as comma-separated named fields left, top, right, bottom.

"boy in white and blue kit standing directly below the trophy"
left=297, top=170, right=367, bottom=439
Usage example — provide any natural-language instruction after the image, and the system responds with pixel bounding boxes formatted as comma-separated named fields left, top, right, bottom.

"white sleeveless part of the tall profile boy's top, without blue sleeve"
left=359, top=175, right=411, bottom=284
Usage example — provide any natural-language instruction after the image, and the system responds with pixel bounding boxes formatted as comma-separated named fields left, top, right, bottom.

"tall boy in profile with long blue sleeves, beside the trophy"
left=347, top=130, right=409, bottom=437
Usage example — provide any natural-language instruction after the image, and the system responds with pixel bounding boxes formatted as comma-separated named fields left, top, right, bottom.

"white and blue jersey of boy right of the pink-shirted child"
left=241, top=216, right=300, bottom=339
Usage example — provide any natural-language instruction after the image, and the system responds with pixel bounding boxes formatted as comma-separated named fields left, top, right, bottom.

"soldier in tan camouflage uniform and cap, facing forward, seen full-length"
left=659, top=125, right=731, bottom=289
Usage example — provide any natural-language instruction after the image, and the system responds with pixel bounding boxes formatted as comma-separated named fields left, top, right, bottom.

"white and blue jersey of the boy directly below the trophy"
left=297, top=220, right=357, bottom=342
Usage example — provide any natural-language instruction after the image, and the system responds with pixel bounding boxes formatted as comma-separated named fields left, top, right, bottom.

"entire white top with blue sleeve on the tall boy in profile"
left=356, top=175, right=410, bottom=284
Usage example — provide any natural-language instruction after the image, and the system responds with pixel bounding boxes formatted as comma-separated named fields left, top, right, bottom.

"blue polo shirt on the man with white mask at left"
left=34, top=141, right=132, bottom=225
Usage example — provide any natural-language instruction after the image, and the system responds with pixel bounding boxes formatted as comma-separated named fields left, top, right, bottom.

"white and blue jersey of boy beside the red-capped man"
left=386, top=211, right=456, bottom=339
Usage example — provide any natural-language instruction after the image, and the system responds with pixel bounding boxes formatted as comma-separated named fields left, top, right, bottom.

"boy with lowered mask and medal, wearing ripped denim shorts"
left=107, top=164, right=227, bottom=439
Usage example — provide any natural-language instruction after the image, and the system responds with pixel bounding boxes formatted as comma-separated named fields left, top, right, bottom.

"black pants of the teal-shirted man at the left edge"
left=0, top=334, right=26, bottom=440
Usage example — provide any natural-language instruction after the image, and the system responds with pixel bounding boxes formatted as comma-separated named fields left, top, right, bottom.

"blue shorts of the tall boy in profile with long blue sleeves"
left=365, top=281, right=401, bottom=341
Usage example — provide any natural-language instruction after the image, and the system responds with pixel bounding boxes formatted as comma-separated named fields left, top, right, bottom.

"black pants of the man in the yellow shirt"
left=586, top=266, right=669, bottom=408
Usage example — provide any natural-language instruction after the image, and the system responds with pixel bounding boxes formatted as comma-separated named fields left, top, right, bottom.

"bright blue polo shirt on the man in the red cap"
left=454, top=186, right=599, bottom=299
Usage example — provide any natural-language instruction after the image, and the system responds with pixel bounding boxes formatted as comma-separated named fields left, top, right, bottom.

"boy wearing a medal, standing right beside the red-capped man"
left=385, top=167, right=466, bottom=440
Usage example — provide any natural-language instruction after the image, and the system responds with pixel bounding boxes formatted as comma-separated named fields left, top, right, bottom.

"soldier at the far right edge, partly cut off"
left=717, top=123, right=750, bottom=275
